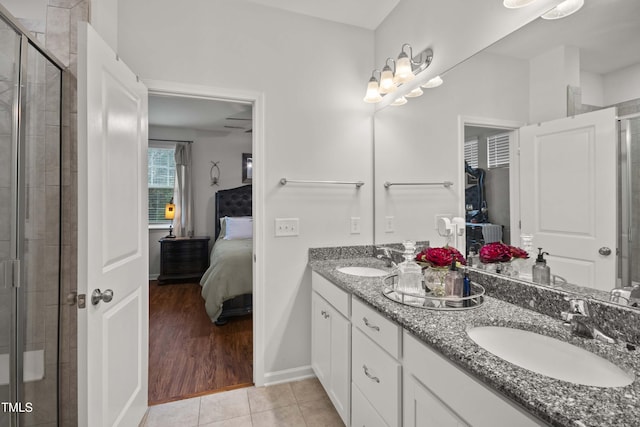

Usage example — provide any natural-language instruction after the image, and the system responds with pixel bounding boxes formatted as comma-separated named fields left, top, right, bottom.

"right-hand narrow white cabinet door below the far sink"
left=329, top=307, right=351, bottom=425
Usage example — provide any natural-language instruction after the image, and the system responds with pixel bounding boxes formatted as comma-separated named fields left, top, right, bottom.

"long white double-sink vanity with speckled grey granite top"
left=309, top=247, right=640, bottom=427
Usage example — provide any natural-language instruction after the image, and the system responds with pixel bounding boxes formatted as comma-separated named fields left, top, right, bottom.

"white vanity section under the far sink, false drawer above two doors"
left=311, top=272, right=351, bottom=426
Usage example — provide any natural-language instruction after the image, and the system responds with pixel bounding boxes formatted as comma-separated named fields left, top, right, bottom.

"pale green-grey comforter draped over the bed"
left=200, top=237, right=253, bottom=322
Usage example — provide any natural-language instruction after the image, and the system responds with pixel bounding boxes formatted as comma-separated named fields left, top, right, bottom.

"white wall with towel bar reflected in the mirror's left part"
left=375, top=53, right=529, bottom=246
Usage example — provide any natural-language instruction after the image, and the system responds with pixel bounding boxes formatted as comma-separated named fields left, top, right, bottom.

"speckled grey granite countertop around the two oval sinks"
left=309, top=257, right=640, bottom=427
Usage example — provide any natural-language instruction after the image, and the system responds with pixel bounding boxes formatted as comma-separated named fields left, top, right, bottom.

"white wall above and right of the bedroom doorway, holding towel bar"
left=118, top=0, right=373, bottom=381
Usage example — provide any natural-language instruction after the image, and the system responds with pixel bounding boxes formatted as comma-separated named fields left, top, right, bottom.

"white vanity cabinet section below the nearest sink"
left=403, top=331, right=547, bottom=427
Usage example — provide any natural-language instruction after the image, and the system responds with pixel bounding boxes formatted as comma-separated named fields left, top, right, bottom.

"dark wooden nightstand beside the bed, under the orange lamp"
left=158, top=236, right=209, bottom=285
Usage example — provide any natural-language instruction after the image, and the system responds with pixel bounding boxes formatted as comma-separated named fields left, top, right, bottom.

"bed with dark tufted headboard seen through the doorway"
left=200, top=185, right=253, bottom=326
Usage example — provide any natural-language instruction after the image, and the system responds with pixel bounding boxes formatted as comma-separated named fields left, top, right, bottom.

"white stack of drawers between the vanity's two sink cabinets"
left=351, top=298, right=402, bottom=427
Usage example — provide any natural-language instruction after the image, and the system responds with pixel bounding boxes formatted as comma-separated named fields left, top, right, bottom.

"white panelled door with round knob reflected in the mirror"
left=520, top=108, right=617, bottom=290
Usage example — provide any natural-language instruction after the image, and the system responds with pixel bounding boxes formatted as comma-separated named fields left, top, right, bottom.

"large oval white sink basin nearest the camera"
left=467, top=326, right=634, bottom=387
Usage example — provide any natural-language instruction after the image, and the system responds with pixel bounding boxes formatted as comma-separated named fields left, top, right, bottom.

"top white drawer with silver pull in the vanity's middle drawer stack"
left=351, top=297, right=402, bottom=359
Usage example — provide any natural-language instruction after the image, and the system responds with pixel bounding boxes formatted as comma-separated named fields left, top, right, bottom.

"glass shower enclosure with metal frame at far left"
left=0, top=8, right=62, bottom=427
